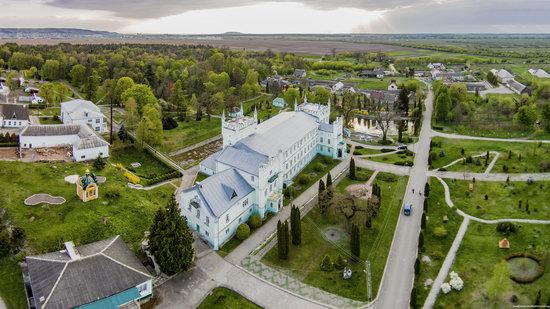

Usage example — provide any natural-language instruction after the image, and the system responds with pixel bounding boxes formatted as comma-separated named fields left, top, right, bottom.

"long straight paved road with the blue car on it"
left=374, top=85, right=433, bottom=308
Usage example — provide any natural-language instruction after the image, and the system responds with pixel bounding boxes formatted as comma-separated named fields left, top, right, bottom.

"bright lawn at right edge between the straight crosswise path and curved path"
left=446, top=180, right=550, bottom=219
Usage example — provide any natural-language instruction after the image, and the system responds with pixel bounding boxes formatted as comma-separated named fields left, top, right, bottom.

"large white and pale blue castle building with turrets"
left=180, top=98, right=346, bottom=250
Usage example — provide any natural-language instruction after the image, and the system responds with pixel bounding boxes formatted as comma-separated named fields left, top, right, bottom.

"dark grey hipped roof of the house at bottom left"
left=26, top=236, right=151, bottom=309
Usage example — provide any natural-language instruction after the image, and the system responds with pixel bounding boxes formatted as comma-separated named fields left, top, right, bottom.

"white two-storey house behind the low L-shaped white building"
left=61, top=99, right=107, bottom=133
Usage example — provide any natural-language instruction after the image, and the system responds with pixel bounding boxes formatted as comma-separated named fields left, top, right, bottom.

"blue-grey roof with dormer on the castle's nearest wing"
left=195, top=168, right=254, bottom=218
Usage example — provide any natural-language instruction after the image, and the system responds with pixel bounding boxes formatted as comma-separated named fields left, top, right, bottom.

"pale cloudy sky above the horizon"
left=0, top=0, right=550, bottom=34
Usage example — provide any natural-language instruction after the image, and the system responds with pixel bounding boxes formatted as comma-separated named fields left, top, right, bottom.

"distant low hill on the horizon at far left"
left=0, top=28, right=122, bottom=39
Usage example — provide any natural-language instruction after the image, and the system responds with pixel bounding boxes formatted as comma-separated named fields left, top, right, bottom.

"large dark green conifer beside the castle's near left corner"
left=149, top=196, right=195, bottom=275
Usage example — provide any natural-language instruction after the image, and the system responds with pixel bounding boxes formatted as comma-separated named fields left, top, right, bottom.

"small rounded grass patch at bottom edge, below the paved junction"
left=197, top=287, right=262, bottom=309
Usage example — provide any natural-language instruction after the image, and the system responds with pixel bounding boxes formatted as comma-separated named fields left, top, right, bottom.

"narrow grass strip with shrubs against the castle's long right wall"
left=285, top=155, right=341, bottom=198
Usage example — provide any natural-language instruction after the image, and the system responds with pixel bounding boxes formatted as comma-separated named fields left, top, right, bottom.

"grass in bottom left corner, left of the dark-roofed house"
left=0, top=257, right=27, bottom=309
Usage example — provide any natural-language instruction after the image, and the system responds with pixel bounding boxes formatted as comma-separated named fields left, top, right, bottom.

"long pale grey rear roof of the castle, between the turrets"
left=239, top=112, right=319, bottom=157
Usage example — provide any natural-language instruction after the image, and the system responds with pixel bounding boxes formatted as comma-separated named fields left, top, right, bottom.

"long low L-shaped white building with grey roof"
left=19, top=124, right=109, bottom=162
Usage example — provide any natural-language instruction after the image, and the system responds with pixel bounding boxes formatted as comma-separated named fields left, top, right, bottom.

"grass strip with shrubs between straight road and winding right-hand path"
left=415, top=178, right=462, bottom=305
